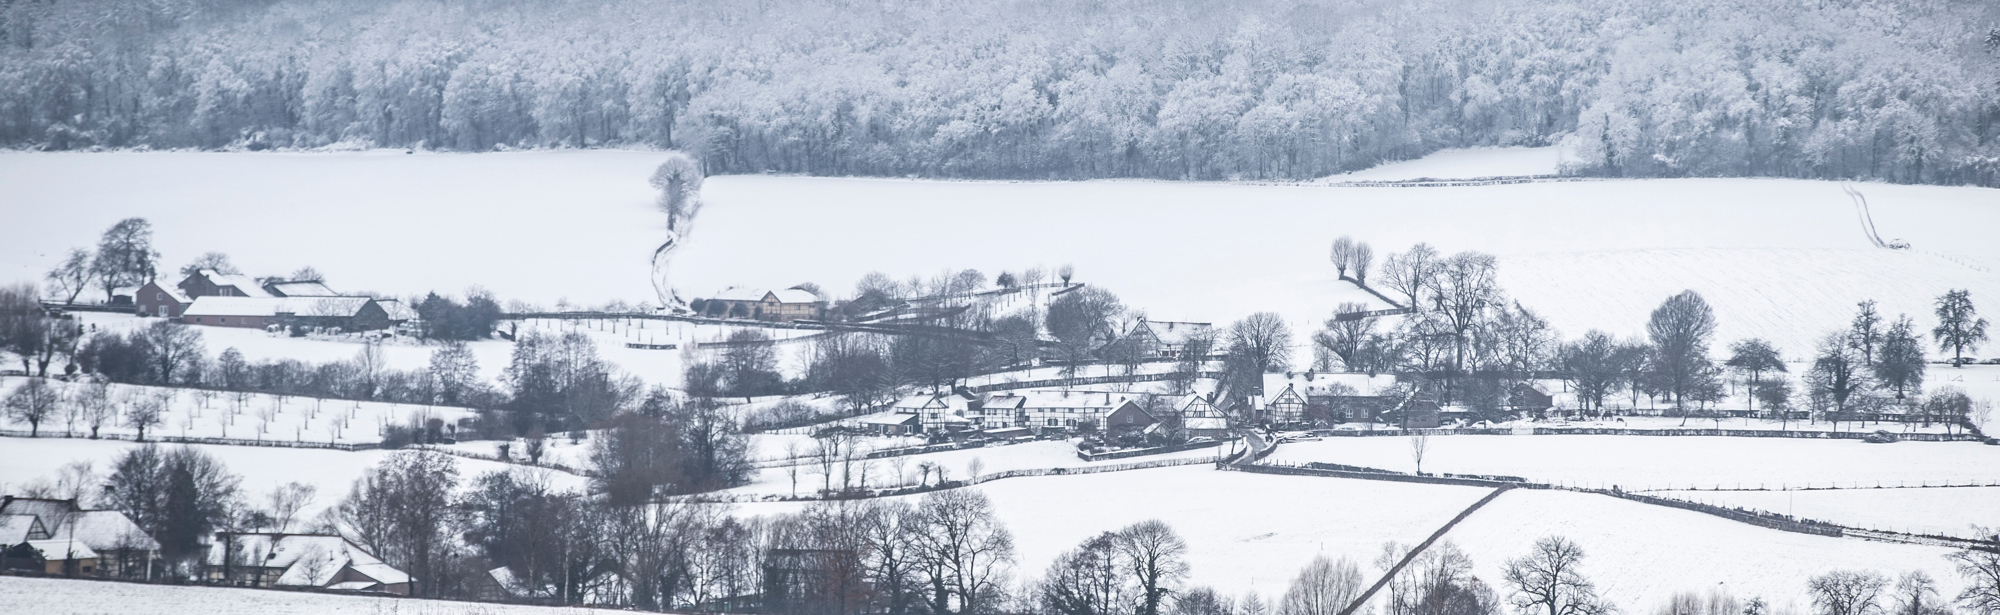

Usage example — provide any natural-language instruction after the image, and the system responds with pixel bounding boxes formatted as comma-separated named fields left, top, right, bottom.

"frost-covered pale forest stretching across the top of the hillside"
left=0, top=0, right=2000, bottom=186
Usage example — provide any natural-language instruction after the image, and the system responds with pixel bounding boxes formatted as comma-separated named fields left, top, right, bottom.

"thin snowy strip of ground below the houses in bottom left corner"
left=0, top=577, right=602, bottom=615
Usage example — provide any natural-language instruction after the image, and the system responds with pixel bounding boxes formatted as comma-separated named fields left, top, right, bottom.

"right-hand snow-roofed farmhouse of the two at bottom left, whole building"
left=204, top=531, right=410, bottom=595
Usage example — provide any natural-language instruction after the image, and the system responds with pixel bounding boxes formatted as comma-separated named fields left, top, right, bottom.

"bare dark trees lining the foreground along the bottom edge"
left=30, top=445, right=2000, bottom=615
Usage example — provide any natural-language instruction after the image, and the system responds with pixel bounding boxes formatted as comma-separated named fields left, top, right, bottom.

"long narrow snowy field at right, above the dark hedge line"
left=1268, top=435, right=2000, bottom=491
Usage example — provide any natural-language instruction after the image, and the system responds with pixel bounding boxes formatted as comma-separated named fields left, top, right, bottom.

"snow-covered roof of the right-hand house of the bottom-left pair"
left=208, top=533, right=410, bottom=589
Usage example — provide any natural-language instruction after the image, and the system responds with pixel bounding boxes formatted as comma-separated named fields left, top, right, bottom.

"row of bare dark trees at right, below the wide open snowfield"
left=1312, top=238, right=1990, bottom=425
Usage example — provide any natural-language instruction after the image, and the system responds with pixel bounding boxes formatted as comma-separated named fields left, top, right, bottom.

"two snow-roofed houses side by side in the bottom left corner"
left=0, top=495, right=412, bottom=595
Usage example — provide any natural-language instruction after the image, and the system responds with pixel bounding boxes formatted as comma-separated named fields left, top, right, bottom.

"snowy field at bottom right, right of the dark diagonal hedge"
left=1446, top=489, right=1962, bottom=613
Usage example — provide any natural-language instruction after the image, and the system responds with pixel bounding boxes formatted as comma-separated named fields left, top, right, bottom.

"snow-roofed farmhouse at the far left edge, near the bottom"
left=0, top=495, right=160, bottom=577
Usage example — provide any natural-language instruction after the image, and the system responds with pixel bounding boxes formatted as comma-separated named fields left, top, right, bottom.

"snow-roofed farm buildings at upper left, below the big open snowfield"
left=132, top=270, right=416, bottom=331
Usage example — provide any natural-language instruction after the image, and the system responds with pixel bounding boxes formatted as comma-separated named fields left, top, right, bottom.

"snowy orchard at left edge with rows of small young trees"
left=0, top=371, right=474, bottom=443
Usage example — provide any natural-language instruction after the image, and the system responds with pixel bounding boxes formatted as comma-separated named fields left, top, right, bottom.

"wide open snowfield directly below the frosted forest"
left=0, top=152, right=2000, bottom=361
